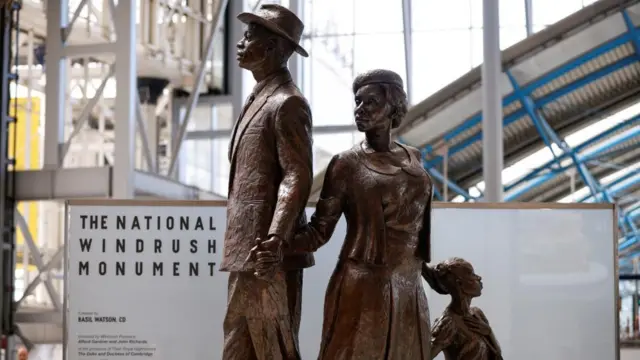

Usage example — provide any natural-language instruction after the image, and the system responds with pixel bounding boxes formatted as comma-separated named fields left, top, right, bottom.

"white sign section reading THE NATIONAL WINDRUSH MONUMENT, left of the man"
left=65, top=202, right=227, bottom=360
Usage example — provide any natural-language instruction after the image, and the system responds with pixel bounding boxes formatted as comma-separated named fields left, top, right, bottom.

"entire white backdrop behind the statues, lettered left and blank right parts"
left=66, top=203, right=617, bottom=360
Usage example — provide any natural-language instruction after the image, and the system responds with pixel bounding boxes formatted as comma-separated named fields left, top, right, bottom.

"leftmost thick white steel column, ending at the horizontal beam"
left=43, top=0, right=69, bottom=169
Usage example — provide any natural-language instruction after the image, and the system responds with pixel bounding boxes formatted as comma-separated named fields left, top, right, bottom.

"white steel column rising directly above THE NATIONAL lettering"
left=113, top=1, right=138, bottom=199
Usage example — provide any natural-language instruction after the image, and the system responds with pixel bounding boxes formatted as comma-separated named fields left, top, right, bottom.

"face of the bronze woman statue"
left=354, top=84, right=391, bottom=132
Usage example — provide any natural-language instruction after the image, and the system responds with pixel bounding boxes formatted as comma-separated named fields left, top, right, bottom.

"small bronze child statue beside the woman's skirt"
left=422, top=257, right=503, bottom=360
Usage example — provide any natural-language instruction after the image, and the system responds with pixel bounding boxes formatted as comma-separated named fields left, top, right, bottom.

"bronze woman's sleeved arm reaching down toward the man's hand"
left=290, top=155, right=347, bottom=252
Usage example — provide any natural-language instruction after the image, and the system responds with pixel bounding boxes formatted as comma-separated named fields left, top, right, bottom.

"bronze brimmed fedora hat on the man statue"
left=238, top=4, right=309, bottom=57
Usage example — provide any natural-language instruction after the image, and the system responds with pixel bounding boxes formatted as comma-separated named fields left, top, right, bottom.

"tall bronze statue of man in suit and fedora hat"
left=221, top=4, right=314, bottom=360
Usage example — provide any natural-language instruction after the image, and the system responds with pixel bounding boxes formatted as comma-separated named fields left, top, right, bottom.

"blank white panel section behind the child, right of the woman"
left=425, top=208, right=618, bottom=360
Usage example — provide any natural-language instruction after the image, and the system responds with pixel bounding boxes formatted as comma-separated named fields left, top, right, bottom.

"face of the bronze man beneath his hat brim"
left=236, top=24, right=270, bottom=71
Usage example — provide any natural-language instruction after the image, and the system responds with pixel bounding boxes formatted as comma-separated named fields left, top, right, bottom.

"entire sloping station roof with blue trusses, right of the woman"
left=313, top=0, right=640, bottom=265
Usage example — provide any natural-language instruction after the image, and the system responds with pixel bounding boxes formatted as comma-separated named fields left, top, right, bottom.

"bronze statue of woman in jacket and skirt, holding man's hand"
left=254, top=70, right=432, bottom=360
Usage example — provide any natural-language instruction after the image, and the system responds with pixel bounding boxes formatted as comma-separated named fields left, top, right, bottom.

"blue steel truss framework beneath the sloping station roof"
left=422, top=10, right=640, bottom=256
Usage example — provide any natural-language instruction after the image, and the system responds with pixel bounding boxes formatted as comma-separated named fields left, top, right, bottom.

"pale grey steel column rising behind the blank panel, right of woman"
left=482, top=0, right=503, bottom=202
